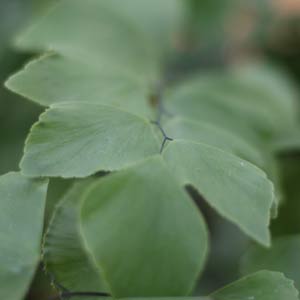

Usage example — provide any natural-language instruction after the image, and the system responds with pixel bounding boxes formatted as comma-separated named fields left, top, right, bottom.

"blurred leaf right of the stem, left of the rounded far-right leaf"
left=164, top=83, right=260, bottom=146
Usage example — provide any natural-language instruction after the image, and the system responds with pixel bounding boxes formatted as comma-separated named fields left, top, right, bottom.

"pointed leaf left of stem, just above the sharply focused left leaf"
left=6, top=54, right=151, bottom=116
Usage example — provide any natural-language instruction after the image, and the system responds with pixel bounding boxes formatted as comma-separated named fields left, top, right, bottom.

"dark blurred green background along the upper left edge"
left=0, top=0, right=44, bottom=174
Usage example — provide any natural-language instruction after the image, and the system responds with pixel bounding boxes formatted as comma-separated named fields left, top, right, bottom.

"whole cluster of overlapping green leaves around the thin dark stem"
left=0, top=0, right=300, bottom=300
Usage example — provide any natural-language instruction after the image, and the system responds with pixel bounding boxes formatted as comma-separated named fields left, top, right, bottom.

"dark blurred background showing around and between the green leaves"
left=0, top=0, right=300, bottom=300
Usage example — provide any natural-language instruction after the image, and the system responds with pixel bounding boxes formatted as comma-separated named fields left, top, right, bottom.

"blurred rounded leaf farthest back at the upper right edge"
left=207, top=66, right=297, bottom=136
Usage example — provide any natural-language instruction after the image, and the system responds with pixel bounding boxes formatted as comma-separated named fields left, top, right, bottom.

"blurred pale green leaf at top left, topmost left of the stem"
left=13, top=0, right=157, bottom=78
